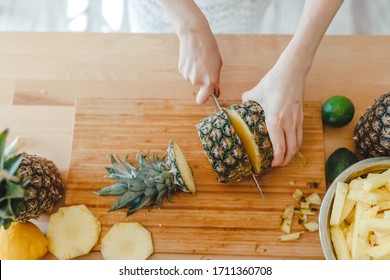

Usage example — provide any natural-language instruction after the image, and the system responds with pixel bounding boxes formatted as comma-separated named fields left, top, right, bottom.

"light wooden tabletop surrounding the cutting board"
left=0, top=33, right=390, bottom=259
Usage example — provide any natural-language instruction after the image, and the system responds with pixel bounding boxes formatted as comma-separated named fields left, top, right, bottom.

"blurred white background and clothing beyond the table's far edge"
left=0, top=0, right=390, bottom=35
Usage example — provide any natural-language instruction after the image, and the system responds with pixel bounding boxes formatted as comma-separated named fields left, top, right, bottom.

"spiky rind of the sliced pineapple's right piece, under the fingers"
left=225, top=100, right=274, bottom=175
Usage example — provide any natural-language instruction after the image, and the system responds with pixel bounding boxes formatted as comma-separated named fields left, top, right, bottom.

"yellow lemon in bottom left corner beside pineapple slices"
left=0, top=222, right=48, bottom=260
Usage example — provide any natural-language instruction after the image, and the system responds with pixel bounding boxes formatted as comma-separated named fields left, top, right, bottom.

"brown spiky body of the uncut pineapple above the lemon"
left=16, top=153, right=64, bottom=222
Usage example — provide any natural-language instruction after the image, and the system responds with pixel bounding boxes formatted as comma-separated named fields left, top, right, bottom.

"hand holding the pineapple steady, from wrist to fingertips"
left=242, top=60, right=306, bottom=167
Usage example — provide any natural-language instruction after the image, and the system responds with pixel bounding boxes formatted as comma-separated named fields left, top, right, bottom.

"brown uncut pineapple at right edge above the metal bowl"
left=354, top=92, right=390, bottom=158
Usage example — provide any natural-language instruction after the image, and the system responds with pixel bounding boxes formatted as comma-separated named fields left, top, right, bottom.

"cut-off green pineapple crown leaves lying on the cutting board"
left=95, top=153, right=176, bottom=215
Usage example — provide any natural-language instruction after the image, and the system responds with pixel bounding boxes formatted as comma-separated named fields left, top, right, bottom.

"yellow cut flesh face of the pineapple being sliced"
left=226, top=109, right=261, bottom=174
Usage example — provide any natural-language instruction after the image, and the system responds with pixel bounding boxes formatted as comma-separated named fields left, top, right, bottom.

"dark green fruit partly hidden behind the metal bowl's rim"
left=325, top=148, right=359, bottom=184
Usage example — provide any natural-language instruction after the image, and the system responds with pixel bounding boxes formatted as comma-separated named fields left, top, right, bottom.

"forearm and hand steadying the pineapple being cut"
left=243, top=0, right=343, bottom=167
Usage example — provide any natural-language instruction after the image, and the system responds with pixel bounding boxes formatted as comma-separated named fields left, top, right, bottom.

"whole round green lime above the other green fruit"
left=322, top=95, right=355, bottom=127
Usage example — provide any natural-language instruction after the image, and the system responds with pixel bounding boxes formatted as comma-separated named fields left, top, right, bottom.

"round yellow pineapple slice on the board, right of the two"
left=101, top=222, right=153, bottom=260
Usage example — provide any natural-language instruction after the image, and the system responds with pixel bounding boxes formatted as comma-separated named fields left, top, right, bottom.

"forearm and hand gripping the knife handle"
left=160, top=0, right=222, bottom=104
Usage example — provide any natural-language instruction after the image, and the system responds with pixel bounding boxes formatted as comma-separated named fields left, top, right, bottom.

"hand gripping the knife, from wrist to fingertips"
left=179, top=25, right=222, bottom=104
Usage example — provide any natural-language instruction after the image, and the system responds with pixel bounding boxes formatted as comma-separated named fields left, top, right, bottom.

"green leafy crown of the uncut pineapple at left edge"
left=0, top=129, right=28, bottom=229
